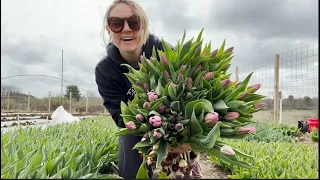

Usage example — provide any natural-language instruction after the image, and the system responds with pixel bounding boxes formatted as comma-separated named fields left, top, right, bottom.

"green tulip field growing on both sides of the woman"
left=1, top=116, right=319, bottom=179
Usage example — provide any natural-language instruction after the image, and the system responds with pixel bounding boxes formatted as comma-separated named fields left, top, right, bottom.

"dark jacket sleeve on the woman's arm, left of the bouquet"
left=95, top=68, right=126, bottom=127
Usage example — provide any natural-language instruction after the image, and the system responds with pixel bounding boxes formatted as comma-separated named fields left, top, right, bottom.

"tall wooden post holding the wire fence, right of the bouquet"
left=274, top=54, right=279, bottom=121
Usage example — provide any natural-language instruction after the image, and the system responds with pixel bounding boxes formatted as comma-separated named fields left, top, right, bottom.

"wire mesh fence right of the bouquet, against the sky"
left=234, top=43, right=319, bottom=123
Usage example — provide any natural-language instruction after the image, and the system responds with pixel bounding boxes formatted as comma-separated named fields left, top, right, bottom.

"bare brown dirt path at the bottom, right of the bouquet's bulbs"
left=200, top=154, right=230, bottom=179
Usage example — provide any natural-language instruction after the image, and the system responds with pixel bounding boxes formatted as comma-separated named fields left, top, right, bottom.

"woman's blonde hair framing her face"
left=102, top=0, right=149, bottom=46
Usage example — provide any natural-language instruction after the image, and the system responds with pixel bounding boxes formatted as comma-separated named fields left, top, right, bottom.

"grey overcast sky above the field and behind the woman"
left=1, top=0, right=319, bottom=97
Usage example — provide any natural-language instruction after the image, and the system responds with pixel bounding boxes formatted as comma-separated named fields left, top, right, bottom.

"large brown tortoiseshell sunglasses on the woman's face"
left=108, top=15, right=140, bottom=33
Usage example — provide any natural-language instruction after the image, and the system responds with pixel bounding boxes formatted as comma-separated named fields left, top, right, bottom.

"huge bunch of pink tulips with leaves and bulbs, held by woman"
left=117, top=30, right=265, bottom=178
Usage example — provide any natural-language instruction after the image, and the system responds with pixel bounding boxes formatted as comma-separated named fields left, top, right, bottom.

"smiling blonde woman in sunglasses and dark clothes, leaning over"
left=95, top=0, right=200, bottom=179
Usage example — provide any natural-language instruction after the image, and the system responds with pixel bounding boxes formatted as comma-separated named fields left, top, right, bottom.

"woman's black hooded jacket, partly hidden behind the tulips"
left=95, top=35, right=163, bottom=127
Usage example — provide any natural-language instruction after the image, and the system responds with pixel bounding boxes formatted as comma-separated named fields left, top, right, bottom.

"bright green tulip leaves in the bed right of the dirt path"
left=211, top=139, right=319, bottom=179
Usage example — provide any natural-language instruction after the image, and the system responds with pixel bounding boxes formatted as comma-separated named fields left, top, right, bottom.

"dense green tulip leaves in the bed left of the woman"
left=1, top=116, right=118, bottom=179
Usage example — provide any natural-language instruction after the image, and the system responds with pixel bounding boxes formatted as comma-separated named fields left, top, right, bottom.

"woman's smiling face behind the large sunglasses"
left=106, top=3, right=141, bottom=53
